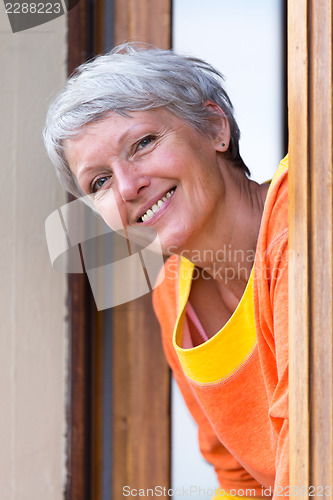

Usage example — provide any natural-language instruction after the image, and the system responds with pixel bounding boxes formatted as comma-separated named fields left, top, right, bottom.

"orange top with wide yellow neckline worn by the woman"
left=153, top=159, right=289, bottom=499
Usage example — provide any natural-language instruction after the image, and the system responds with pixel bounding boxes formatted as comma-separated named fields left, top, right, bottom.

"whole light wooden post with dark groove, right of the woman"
left=288, top=0, right=333, bottom=498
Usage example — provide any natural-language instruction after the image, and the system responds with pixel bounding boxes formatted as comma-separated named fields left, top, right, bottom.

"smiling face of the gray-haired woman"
left=64, top=108, right=224, bottom=253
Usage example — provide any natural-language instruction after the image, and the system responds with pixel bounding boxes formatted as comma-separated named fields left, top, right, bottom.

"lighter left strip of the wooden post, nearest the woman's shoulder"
left=288, top=0, right=310, bottom=488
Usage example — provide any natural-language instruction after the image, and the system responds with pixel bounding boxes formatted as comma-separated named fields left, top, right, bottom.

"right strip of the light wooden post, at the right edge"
left=309, top=0, right=333, bottom=486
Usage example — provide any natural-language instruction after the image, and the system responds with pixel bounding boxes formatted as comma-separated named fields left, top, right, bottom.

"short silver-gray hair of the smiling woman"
left=43, top=43, right=250, bottom=196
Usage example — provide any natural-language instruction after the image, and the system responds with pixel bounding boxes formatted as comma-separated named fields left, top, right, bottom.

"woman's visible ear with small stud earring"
left=203, top=100, right=230, bottom=153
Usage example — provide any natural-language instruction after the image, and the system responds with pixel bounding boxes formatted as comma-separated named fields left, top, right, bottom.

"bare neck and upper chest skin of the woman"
left=180, top=165, right=268, bottom=302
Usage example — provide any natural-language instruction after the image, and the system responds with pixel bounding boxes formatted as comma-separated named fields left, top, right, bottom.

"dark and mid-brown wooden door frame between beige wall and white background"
left=66, top=0, right=171, bottom=500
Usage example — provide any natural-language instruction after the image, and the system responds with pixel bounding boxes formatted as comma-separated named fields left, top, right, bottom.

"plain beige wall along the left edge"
left=0, top=7, right=67, bottom=500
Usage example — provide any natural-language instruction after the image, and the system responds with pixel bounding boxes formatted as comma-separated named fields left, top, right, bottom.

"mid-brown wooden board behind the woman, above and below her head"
left=112, top=0, right=171, bottom=499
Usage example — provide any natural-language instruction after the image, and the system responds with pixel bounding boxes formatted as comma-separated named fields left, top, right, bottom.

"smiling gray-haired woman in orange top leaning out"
left=44, top=45, right=288, bottom=498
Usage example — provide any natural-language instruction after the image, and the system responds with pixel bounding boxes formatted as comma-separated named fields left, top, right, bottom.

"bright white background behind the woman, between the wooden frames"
left=172, top=0, right=285, bottom=500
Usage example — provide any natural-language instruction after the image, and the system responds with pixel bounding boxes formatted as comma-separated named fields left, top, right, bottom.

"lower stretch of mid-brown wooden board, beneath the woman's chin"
left=113, top=295, right=170, bottom=498
